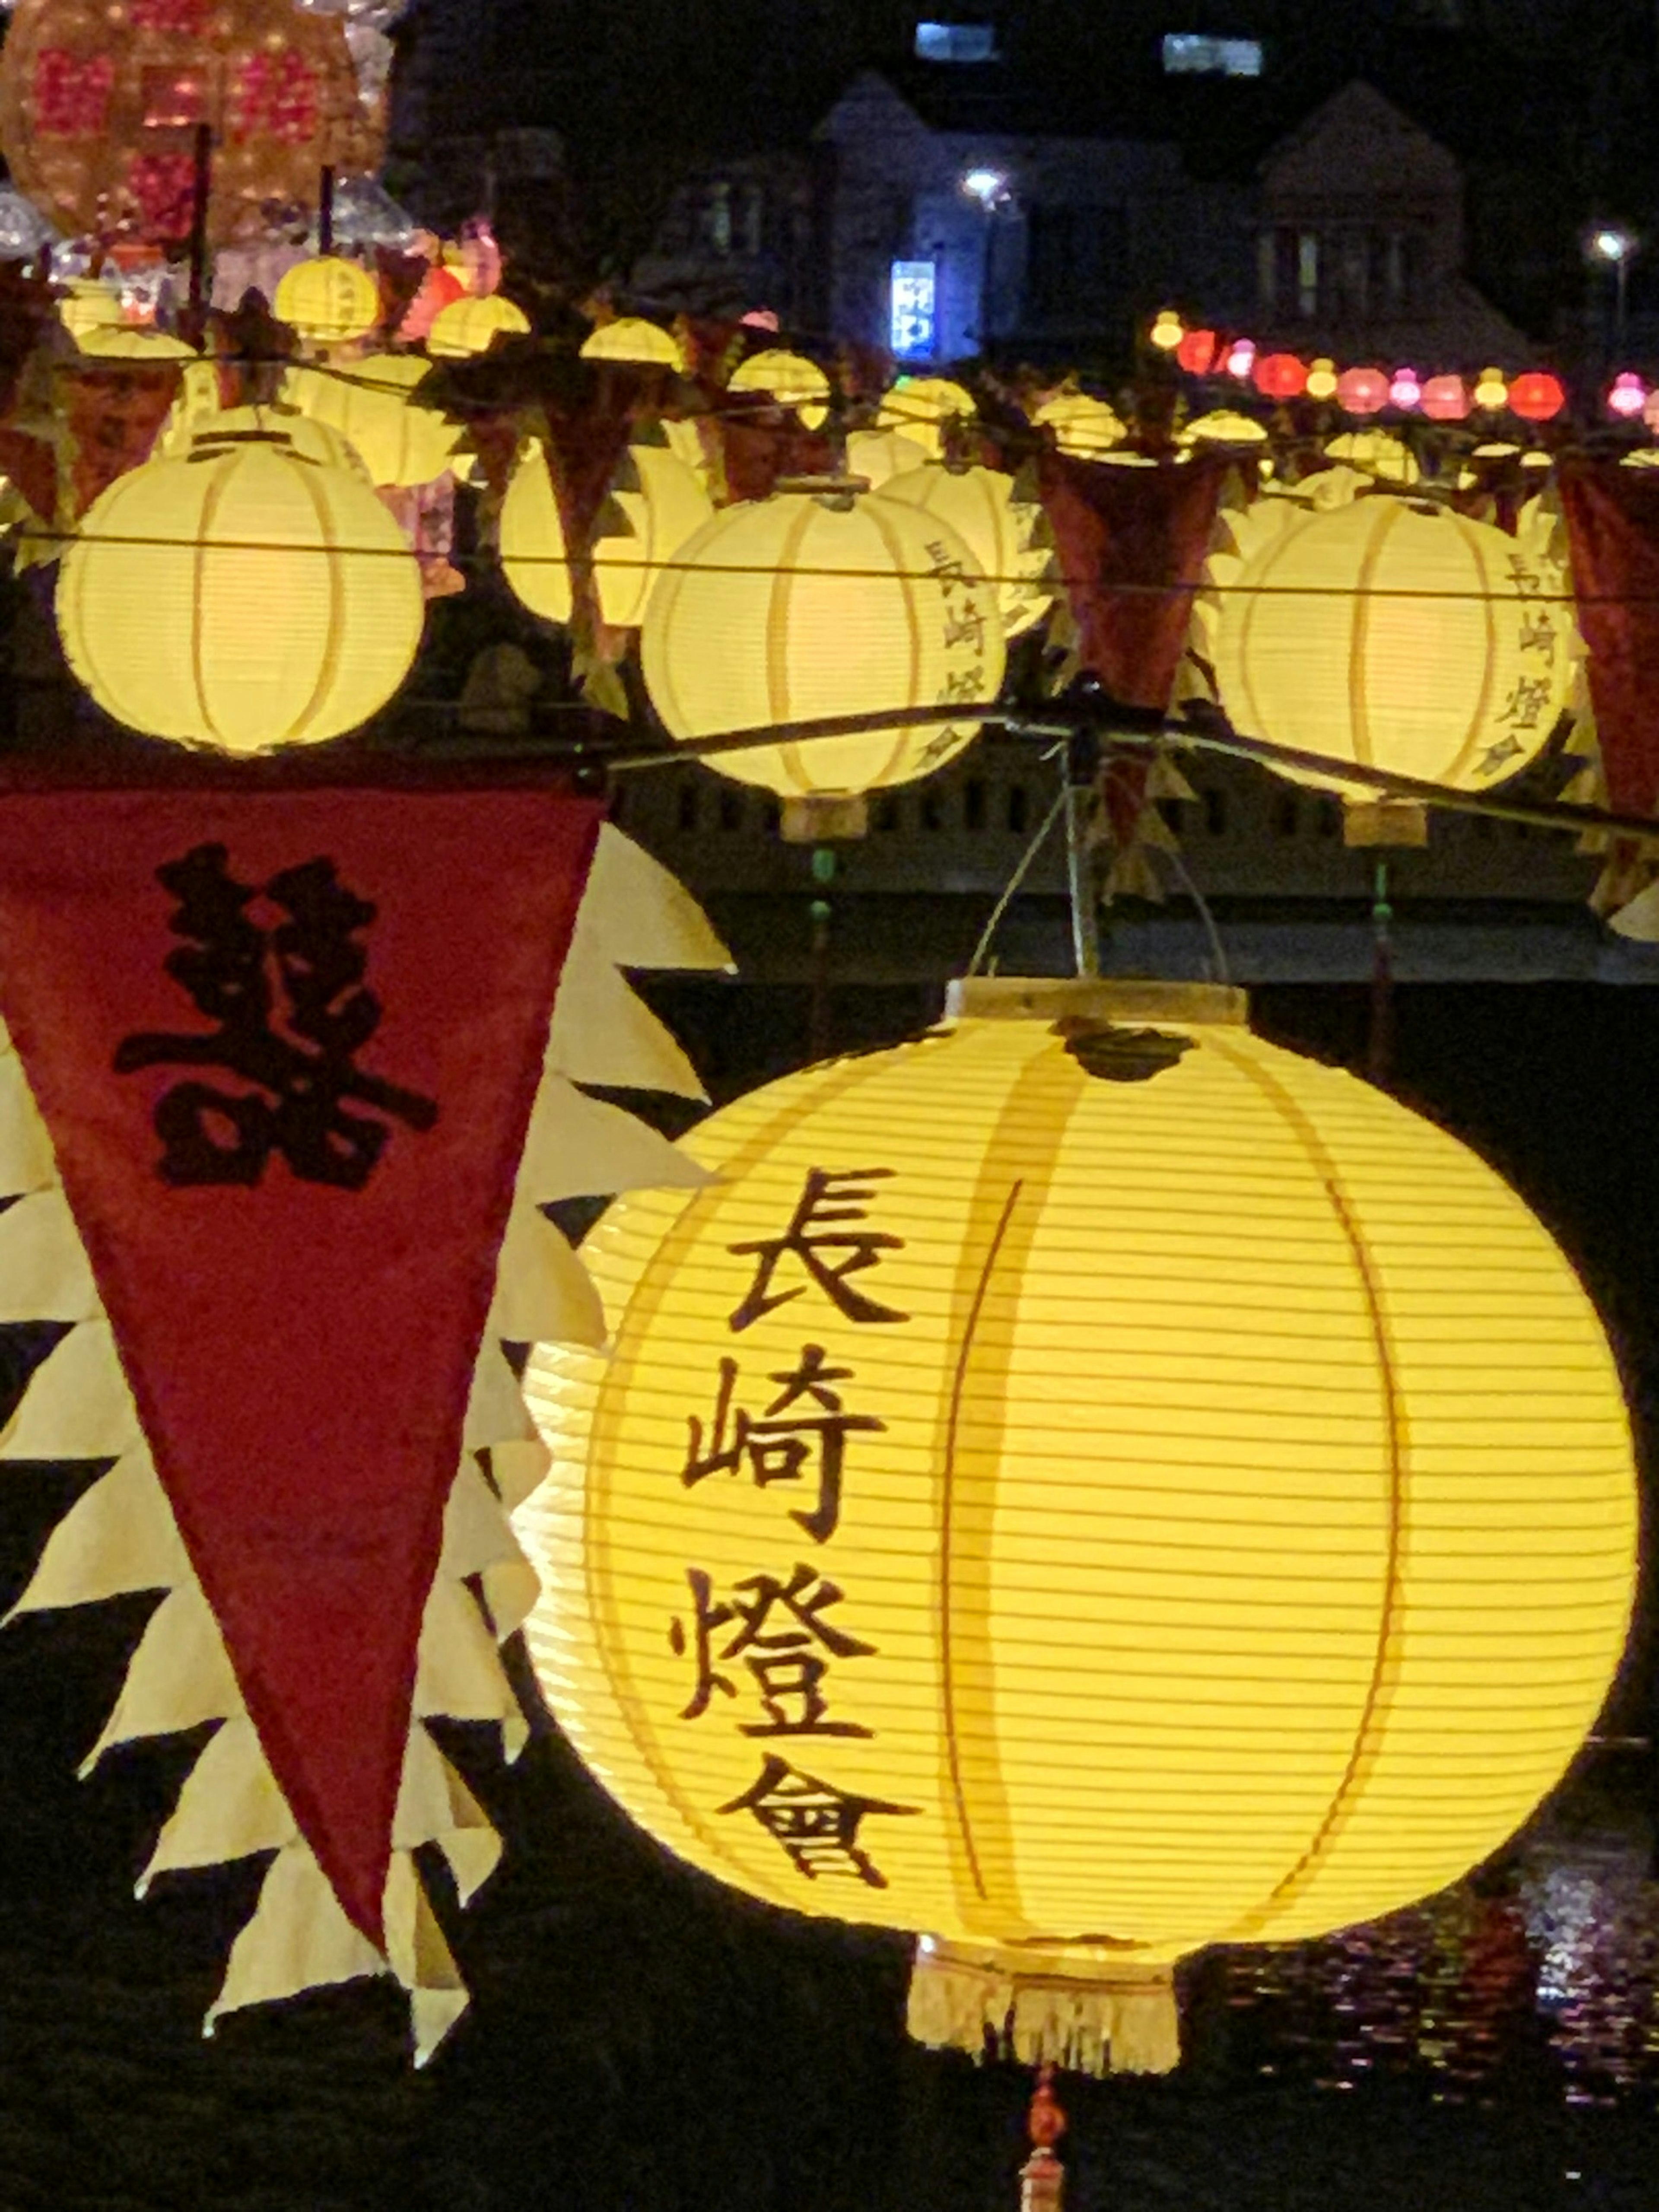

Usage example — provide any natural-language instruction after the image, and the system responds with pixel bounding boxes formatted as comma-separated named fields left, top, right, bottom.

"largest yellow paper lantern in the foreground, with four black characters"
left=520, top=982, right=1637, bottom=2064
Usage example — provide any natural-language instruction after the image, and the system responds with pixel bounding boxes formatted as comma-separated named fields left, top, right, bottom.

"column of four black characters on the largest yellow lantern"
left=668, top=1168, right=916, bottom=1889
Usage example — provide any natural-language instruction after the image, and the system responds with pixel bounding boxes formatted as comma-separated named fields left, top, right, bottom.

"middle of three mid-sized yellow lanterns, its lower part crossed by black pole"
left=639, top=491, right=1004, bottom=798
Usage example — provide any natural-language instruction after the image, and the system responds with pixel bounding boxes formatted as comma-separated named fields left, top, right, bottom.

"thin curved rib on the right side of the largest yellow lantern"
left=1205, top=1037, right=1409, bottom=1942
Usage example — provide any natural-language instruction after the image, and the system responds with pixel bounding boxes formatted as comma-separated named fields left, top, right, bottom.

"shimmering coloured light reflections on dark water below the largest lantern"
left=1221, top=1761, right=1659, bottom=2106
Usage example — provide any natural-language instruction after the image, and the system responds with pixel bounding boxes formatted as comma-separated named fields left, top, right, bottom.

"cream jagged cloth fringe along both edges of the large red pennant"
left=0, top=827, right=730, bottom=2066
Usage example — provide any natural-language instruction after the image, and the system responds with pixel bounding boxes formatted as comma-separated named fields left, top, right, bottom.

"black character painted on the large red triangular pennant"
left=115, top=845, right=438, bottom=1190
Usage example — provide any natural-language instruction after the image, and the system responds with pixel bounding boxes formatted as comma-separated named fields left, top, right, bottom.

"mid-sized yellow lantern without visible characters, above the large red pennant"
left=57, top=409, right=423, bottom=752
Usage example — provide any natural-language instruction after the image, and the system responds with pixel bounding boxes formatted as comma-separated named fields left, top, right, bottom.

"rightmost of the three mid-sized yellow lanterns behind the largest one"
left=1199, top=493, right=1577, bottom=796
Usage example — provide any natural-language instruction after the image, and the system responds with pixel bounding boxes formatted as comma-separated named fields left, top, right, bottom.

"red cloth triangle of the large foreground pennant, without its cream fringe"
left=0, top=770, right=602, bottom=1942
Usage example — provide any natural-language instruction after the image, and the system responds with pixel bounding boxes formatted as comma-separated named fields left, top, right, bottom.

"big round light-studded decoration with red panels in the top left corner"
left=0, top=0, right=381, bottom=243
